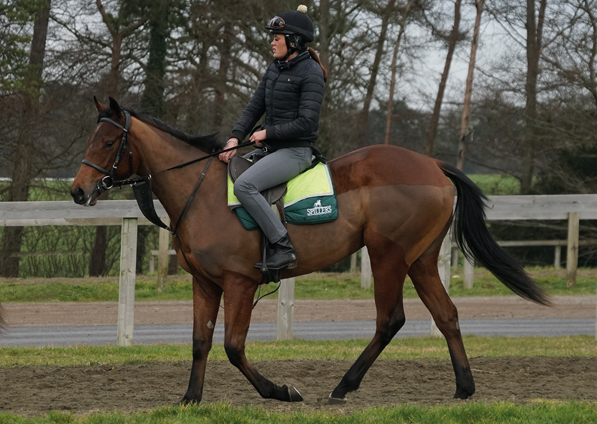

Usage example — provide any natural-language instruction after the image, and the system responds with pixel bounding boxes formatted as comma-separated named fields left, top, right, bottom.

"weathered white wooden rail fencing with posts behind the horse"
left=0, top=194, right=597, bottom=346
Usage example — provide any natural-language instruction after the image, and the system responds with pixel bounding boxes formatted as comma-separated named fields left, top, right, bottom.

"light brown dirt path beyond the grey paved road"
left=3, top=296, right=596, bottom=327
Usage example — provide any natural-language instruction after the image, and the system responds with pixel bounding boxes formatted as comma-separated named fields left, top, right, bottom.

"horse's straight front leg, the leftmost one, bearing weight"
left=181, top=278, right=222, bottom=404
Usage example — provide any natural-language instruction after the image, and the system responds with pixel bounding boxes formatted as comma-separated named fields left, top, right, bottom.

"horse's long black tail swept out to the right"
left=439, top=162, right=550, bottom=305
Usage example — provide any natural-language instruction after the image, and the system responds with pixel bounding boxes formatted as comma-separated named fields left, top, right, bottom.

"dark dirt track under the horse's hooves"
left=0, top=357, right=597, bottom=415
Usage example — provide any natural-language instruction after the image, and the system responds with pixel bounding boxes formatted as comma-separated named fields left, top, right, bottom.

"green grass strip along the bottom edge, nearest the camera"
left=0, top=400, right=597, bottom=424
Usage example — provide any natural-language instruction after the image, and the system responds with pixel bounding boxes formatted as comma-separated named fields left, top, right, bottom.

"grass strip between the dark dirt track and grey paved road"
left=0, top=336, right=597, bottom=368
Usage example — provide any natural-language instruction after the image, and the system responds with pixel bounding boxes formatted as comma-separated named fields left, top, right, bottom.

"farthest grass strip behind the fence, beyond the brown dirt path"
left=0, top=267, right=596, bottom=302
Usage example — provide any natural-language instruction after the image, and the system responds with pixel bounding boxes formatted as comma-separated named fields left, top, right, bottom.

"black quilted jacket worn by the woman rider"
left=232, top=52, right=325, bottom=149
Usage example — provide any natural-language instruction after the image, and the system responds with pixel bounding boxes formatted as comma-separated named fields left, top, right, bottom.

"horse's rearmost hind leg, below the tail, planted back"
left=408, top=237, right=475, bottom=399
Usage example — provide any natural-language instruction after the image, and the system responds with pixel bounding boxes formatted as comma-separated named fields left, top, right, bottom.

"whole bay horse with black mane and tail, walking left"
left=71, top=99, right=549, bottom=403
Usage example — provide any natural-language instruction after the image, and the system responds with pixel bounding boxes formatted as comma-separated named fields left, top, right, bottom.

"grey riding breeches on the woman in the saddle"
left=234, top=147, right=313, bottom=243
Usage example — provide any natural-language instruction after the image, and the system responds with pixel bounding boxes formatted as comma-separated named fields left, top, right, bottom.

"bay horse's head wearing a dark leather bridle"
left=70, top=97, right=138, bottom=206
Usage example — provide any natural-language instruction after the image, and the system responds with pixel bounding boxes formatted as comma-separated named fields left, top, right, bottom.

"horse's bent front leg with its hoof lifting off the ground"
left=224, top=277, right=303, bottom=402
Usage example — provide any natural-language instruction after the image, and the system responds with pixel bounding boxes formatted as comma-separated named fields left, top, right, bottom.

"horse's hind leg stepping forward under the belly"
left=330, top=235, right=408, bottom=401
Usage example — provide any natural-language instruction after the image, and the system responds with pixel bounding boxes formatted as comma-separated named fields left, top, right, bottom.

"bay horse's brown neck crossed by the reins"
left=135, top=123, right=225, bottom=225
